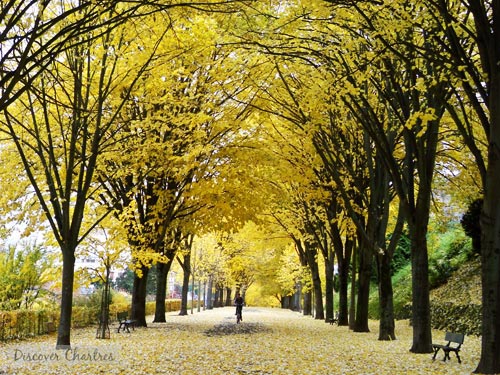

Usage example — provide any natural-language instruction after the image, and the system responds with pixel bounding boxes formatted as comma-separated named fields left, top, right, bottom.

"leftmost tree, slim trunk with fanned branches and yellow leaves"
left=1, top=9, right=168, bottom=348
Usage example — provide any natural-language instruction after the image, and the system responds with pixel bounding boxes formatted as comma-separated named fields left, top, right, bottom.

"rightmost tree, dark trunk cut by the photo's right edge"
left=404, top=0, right=500, bottom=374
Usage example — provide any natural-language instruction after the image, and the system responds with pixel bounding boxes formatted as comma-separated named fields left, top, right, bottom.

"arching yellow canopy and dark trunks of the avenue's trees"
left=0, top=0, right=500, bottom=372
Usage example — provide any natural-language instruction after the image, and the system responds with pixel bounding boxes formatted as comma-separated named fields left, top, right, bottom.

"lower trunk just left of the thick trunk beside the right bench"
left=377, top=254, right=396, bottom=340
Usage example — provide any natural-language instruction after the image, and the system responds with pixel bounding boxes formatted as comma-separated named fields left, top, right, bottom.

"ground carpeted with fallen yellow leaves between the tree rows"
left=0, top=307, right=480, bottom=375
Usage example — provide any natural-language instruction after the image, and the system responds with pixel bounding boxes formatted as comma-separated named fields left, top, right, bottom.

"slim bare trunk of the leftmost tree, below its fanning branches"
left=56, top=248, right=75, bottom=349
